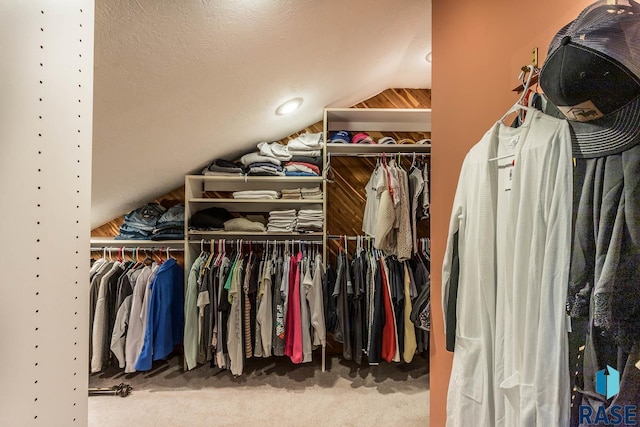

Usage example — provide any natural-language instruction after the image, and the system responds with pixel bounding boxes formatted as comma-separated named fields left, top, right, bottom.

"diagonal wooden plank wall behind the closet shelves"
left=91, top=89, right=431, bottom=239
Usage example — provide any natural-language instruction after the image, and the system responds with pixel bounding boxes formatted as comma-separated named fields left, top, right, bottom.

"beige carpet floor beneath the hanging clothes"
left=89, top=355, right=429, bottom=427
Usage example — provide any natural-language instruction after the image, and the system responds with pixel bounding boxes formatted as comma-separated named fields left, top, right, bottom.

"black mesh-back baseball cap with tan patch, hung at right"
left=540, top=0, right=640, bottom=158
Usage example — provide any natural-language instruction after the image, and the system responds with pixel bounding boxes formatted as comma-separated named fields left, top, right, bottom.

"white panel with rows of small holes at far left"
left=0, top=0, right=94, bottom=426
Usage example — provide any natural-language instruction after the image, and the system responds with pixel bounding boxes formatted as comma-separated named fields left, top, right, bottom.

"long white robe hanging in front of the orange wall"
left=442, top=111, right=572, bottom=427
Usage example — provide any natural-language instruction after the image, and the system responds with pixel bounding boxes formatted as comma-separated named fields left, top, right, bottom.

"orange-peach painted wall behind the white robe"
left=430, top=0, right=592, bottom=427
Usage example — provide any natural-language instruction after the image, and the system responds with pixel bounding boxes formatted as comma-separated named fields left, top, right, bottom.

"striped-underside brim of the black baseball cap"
left=545, top=96, right=640, bottom=159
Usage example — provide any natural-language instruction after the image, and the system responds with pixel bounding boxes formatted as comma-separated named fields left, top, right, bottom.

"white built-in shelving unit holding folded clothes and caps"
left=179, top=108, right=431, bottom=371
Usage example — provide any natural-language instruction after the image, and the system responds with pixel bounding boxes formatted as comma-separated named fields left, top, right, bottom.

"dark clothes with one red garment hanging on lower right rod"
left=325, top=242, right=428, bottom=365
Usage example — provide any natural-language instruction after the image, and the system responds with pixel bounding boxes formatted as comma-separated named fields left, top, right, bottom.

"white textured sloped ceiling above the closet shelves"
left=91, top=0, right=431, bottom=228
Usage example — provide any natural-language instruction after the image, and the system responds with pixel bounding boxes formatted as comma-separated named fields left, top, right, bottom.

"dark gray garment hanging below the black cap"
left=567, top=145, right=640, bottom=422
